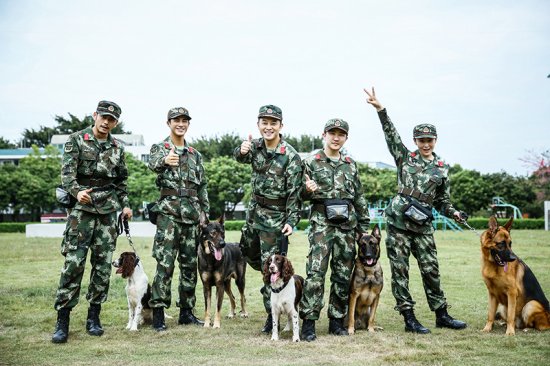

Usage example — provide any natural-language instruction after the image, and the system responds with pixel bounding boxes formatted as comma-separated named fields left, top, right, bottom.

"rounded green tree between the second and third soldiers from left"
left=204, top=156, right=252, bottom=217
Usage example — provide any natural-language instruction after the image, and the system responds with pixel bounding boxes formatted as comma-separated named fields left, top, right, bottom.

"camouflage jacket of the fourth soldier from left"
left=303, top=149, right=370, bottom=234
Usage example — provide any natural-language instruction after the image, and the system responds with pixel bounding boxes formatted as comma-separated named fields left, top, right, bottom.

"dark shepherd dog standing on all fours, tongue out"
left=197, top=216, right=248, bottom=328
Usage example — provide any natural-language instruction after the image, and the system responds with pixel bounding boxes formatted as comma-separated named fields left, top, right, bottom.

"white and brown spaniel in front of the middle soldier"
left=264, top=254, right=304, bottom=342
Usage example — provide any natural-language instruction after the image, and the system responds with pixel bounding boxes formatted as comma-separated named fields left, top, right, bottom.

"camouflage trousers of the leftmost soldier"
left=54, top=210, right=117, bottom=310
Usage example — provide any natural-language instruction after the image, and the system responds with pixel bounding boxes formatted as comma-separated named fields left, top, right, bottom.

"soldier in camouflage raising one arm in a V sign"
left=365, top=88, right=466, bottom=334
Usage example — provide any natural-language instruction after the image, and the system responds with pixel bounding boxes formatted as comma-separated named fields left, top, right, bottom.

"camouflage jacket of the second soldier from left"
left=149, top=137, right=210, bottom=224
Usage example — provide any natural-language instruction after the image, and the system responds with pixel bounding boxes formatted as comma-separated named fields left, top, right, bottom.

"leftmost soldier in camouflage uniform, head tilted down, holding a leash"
left=52, top=101, right=132, bottom=343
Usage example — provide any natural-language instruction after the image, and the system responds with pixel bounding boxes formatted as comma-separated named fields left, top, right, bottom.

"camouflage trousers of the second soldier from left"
left=149, top=213, right=198, bottom=309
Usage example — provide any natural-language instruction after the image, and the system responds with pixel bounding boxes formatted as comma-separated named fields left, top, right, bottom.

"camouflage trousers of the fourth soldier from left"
left=300, top=222, right=356, bottom=320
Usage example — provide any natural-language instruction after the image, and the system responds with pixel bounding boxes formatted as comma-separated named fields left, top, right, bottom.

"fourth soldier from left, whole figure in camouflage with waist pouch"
left=300, top=119, right=370, bottom=342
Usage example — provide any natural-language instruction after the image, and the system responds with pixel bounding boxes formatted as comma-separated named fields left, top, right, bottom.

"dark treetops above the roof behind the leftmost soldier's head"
left=21, top=113, right=130, bottom=147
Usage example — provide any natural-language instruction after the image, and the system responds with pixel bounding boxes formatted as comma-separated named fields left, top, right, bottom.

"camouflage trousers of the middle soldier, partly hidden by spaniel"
left=241, top=224, right=282, bottom=314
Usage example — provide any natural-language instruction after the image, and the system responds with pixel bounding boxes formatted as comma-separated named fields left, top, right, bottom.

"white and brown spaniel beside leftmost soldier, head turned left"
left=112, top=252, right=152, bottom=331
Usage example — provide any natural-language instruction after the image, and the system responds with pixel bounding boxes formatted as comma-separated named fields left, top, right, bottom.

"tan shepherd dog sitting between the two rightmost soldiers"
left=344, top=224, right=384, bottom=334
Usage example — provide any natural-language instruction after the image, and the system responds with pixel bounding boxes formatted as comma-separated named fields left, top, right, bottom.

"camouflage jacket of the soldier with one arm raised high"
left=378, top=109, right=456, bottom=234
